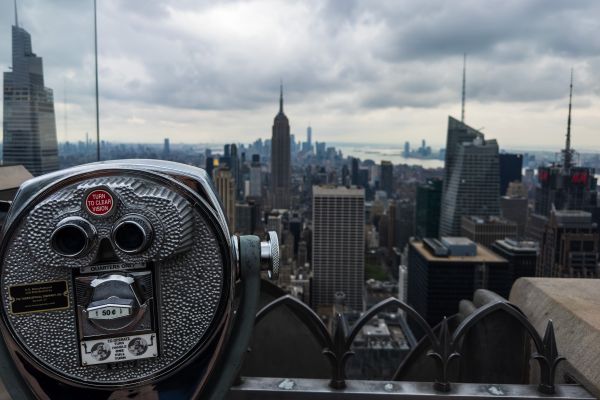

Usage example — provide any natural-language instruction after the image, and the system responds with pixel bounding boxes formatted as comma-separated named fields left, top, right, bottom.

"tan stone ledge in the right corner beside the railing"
left=510, top=278, right=600, bottom=397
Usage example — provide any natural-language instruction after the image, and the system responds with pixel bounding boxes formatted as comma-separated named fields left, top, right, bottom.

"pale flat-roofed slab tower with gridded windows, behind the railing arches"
left=312, top=186, right=365, bottom=310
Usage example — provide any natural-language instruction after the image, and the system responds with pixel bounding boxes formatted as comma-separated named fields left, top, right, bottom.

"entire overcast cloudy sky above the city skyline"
left=0, top=0, right=600, bottom=151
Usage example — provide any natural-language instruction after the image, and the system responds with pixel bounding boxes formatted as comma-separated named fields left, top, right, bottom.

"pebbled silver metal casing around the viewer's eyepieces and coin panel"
left=0, top=160, right=238, bottom=396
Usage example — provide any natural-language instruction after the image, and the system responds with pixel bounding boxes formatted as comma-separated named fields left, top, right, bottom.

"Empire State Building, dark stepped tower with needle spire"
left=271, top=85, right=291, bottom=209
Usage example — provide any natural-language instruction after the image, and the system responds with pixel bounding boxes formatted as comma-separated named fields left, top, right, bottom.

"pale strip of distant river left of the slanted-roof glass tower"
left=335, top=143, right=444, bottom=168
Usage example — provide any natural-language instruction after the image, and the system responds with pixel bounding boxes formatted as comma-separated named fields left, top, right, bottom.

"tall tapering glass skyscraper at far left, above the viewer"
left=3, top=4, right=58, bottom=175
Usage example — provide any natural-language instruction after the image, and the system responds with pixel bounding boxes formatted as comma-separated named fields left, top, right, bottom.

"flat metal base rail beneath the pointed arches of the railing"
left=227, top=378, right=594, bottom=400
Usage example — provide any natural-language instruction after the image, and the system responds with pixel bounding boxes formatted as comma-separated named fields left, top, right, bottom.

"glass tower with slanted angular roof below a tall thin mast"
left=440, top=117, right=500, bottom=236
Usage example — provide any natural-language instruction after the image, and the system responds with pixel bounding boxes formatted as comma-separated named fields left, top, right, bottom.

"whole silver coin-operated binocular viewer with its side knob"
left=0, top=160, right=279, bottom=399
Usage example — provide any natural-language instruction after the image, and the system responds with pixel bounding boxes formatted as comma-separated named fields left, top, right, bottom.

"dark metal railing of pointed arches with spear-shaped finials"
left=227, top=295, right=592, bottom=398
